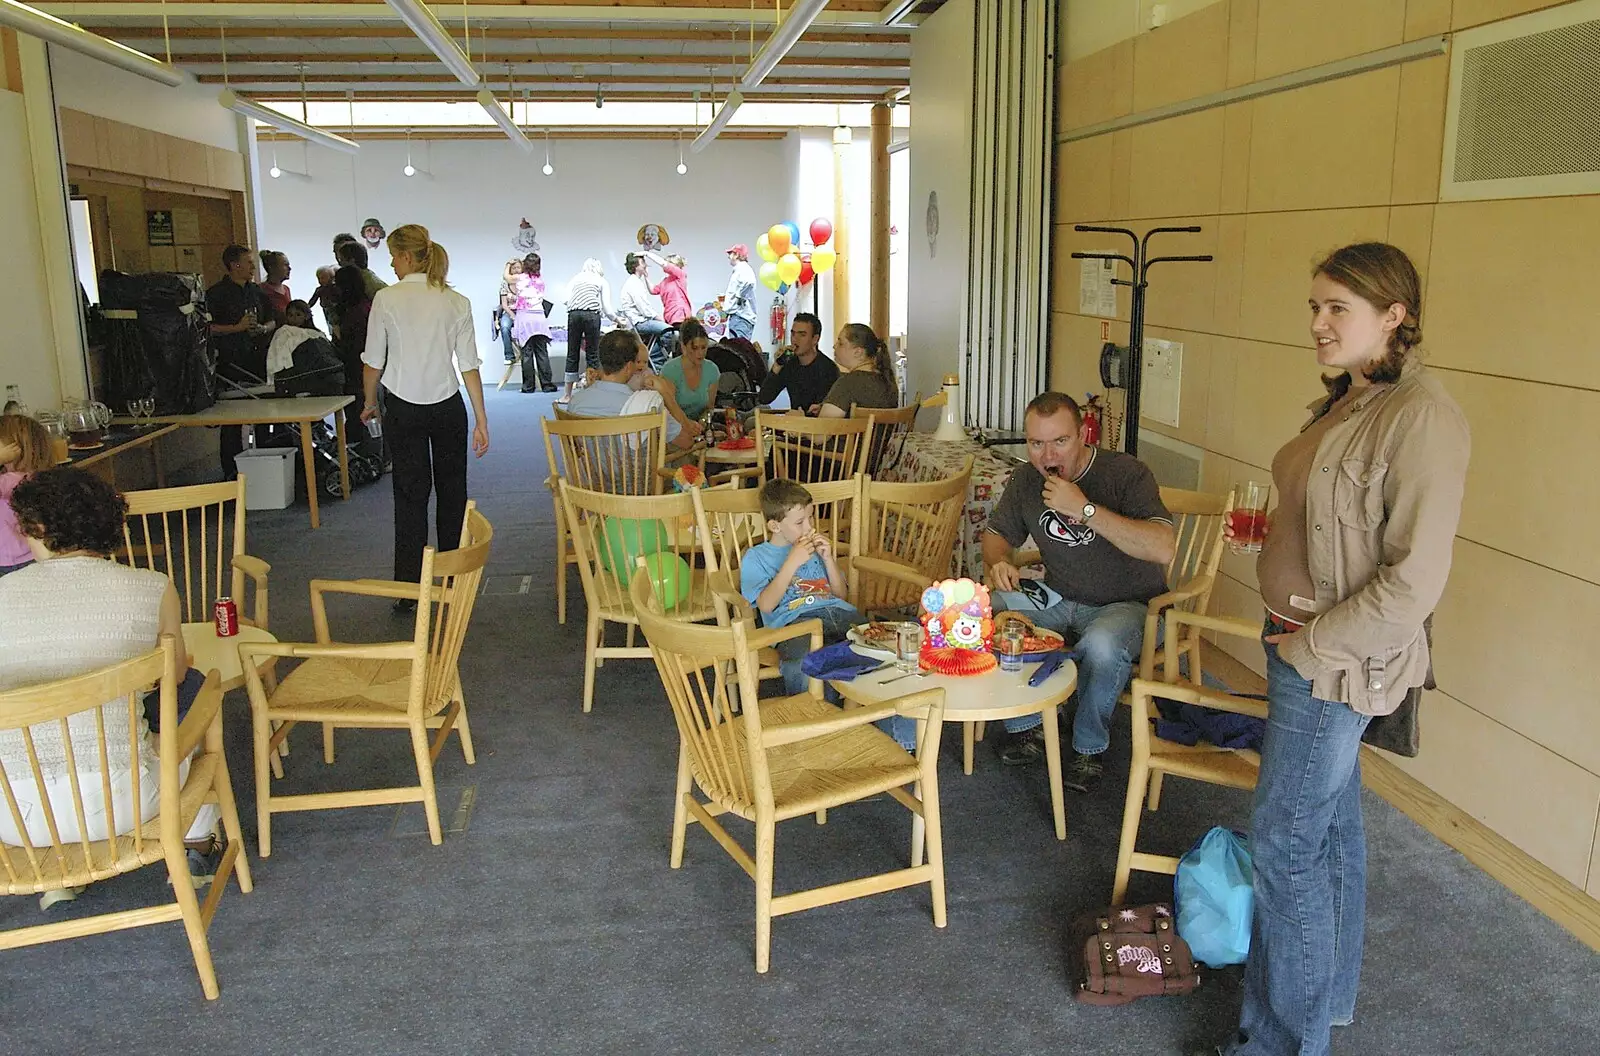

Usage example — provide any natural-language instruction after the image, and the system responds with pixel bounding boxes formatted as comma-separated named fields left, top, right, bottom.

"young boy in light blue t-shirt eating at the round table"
left=739, top=480, right=862, bottom=693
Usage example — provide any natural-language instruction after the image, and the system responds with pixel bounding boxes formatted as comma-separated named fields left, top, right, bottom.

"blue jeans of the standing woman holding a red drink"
left=1227, top=621, right=1371, bottom=1056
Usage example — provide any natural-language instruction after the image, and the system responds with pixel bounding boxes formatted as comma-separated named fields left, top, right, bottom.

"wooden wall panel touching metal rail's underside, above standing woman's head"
left=1250, top=67, right=1400, bottom=211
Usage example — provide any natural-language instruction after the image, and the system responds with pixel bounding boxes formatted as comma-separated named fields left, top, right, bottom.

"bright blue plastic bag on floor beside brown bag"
left=1176, top=826, right=1254, bottom=968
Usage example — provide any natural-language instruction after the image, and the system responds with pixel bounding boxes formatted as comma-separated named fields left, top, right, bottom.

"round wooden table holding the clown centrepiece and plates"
left=829, top=661, right=1078, bottom=840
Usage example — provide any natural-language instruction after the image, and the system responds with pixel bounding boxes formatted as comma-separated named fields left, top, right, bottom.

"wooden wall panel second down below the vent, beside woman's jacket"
left=1440, top=371, right=1600, bottom=585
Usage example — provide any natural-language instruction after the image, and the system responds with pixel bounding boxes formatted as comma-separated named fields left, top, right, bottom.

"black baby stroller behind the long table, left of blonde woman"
left=218, top=326, right=384, bottom=498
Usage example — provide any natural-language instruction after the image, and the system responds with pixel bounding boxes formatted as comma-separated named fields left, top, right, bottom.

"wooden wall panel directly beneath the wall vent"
left=1424, top=195, right=1600, bottom=389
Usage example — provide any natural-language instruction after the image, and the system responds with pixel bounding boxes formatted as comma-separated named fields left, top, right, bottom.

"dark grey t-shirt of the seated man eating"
left=989, top=448, right=1173, bottom=605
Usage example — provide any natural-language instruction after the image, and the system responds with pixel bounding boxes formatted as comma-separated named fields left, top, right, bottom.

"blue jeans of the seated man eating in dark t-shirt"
left=1005, top=600, right=1149, bottom=755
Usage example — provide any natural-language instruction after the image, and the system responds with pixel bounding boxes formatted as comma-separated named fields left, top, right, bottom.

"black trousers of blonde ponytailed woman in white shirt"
left=384, top=392, right=467, bottom=582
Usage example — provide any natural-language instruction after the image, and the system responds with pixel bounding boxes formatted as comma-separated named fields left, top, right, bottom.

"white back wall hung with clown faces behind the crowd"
left=258, top=139, right=794, bottom=363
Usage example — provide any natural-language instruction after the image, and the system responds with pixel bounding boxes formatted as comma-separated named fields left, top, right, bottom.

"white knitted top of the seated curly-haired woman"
left=0, top=557, right=166, bottom=781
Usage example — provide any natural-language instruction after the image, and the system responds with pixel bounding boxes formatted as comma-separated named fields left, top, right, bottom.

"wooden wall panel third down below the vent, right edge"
left=1434, top=539, right=1600, bottom=774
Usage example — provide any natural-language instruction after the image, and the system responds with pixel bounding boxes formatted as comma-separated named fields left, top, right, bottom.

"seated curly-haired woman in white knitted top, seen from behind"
left=0, top=469, right=218, bottom=909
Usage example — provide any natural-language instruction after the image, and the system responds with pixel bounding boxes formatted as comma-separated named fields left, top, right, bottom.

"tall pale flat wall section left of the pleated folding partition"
left=906, top=0, right=973, bottom=406
